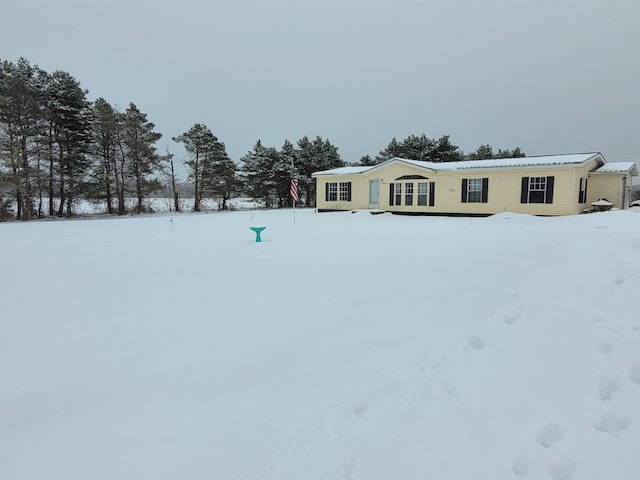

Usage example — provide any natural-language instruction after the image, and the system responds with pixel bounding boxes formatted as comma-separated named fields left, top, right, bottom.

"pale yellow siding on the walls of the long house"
left=317, top=159, right=631, bottom=215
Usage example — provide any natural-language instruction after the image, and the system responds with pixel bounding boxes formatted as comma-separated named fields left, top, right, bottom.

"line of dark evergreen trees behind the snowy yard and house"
left=0, top=58, right=525, bottom=221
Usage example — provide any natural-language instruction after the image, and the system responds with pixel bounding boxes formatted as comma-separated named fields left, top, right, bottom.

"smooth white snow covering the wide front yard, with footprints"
left=0, top=209, right=640, bottom=480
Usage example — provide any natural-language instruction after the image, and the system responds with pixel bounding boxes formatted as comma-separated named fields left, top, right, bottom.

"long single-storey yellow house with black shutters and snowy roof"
left=312, top=153, right=638, bottom=216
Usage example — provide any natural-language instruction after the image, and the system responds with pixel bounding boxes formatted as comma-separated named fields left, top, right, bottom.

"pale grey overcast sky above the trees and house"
left=0, top=0, right=640, bottom=174
